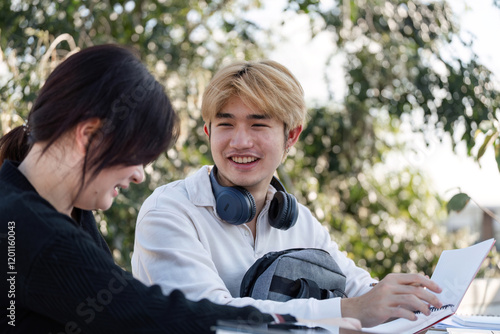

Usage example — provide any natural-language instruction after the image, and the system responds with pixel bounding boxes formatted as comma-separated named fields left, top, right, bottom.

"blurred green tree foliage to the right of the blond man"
left=280, top=0, right=500, bottom=276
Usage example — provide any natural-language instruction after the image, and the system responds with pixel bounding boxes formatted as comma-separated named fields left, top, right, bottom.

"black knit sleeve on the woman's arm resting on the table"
left=22, top=228, right=273, bottom=334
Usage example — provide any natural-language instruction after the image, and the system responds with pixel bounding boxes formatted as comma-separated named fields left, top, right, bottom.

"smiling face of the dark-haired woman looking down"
left=74, top=165, right=144, bottom=210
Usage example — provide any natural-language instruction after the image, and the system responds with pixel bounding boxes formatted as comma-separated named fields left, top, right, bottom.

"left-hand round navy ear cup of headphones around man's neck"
left=215, top=187, right=257, bottom=225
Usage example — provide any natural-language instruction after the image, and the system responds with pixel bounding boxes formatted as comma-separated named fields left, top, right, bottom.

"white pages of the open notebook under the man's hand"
left=363, top=239, right=495, bottom=333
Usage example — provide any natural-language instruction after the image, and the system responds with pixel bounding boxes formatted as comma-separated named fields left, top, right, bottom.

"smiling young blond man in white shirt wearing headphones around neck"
left=132, top=60, right=441, bottom=327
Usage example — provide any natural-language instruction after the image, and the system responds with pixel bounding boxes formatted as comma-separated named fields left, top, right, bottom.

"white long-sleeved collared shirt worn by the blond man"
left=132, top=166, right=375, bottom=319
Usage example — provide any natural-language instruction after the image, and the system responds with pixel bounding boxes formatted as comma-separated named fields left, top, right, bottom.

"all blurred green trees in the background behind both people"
left=0, top=0, right=498, bottom=277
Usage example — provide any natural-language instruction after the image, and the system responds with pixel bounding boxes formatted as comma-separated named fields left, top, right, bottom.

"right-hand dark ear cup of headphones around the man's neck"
left=269, top=191, right=299, bottom=230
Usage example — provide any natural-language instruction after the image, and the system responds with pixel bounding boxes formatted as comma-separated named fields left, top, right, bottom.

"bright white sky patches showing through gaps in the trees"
left=251, top=0, right=500, bottom=206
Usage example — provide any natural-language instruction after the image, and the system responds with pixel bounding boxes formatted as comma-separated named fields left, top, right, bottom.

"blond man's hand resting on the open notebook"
left=341, top=274, right=443, bottom=327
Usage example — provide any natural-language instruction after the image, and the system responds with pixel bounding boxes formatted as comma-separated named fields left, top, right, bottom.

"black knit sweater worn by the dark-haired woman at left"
left=0, top=161, right=293, bottom=334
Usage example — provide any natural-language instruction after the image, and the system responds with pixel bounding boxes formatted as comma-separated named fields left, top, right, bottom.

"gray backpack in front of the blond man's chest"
left=240, top=248, right=347, bottom=302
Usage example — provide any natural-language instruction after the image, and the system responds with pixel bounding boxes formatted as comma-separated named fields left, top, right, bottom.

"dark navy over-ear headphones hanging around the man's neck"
left=210, top=166, right=299, bottom=230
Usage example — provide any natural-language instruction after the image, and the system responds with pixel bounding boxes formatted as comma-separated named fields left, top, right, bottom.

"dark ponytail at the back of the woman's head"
left=0, top=125, right=30, bottom=166
